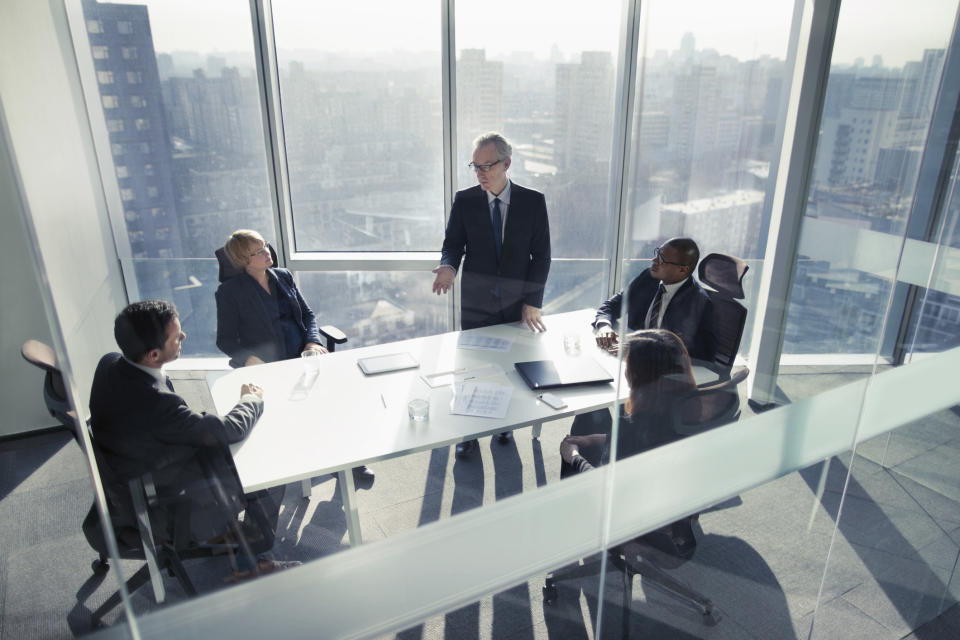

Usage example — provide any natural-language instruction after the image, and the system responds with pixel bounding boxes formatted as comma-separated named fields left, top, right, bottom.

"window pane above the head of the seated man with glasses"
left=625, top=1, right=792, bottom=259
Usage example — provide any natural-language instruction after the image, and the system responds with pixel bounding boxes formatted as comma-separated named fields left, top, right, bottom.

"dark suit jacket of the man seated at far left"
left=90, top=353, right=263, bottom=540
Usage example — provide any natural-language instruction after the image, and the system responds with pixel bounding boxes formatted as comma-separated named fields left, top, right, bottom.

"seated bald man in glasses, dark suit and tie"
left=593, top=238, right=715, bottom=362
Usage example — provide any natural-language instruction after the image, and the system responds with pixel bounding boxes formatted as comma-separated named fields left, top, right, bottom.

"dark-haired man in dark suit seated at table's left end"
left=90, top=300, right=300, bottom=579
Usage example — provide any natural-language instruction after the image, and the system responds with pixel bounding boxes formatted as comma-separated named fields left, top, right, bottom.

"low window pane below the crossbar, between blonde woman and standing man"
left=298, top=271, right=450, bottom=349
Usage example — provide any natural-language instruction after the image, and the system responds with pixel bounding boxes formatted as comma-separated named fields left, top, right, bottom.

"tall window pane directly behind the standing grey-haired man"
left=455, top=0, right=621, bottom=309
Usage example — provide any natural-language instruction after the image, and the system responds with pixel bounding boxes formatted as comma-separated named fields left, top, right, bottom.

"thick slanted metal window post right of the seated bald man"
left=747, top=0, right=840, bottom=404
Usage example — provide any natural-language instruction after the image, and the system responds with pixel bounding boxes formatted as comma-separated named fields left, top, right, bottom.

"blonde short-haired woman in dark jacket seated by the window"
left=217, top=229, right=327, bottom=367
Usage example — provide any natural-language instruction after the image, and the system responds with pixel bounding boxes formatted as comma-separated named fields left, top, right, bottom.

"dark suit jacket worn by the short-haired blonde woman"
left=216, top=268, right=323, bottom=368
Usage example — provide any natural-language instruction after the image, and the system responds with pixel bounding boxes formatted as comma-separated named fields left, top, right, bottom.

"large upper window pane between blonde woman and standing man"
left=272, top=0, right=443, bottom=251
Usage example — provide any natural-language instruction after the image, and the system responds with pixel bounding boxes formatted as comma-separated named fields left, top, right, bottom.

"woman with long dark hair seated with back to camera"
left=560, top=329, right=696, bottom=470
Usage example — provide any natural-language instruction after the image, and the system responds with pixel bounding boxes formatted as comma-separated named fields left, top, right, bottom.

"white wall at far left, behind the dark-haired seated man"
left=0, top=0, right=126, bottom=430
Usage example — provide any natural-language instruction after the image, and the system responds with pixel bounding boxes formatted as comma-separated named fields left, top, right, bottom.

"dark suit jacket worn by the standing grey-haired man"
left=440, top=183, right=550, bottom=329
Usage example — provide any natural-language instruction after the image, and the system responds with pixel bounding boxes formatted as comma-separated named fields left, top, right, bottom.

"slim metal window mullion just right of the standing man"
left=607, top=0, right=641, bottom=298
